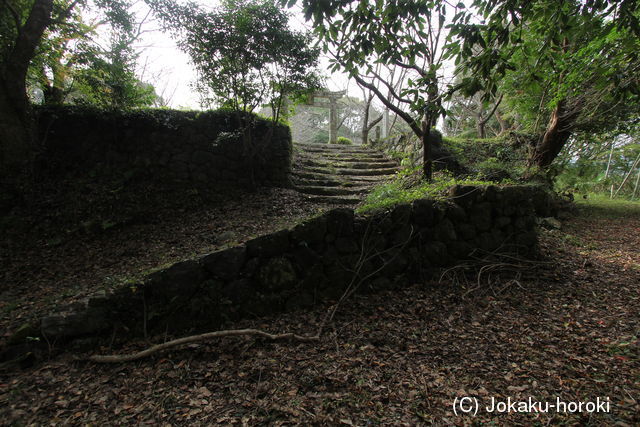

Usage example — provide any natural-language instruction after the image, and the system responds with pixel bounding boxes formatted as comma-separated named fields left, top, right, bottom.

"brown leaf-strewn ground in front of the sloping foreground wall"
left=0, top=196, right=640, bottom=426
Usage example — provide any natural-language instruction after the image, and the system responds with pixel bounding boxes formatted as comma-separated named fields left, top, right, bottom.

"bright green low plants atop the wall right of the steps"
left=356, top=167, right=495, bottom=213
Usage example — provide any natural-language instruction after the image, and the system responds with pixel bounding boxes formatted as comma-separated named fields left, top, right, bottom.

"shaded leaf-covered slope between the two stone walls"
left=0, top=181, right=332, bottom=346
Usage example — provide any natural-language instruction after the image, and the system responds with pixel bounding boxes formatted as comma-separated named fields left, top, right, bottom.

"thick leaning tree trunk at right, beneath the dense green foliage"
left=530, top=100, right=576, bottom=169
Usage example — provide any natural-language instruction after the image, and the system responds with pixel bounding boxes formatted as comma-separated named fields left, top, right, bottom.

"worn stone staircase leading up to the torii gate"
left=292, top=144, right=400, bottom=204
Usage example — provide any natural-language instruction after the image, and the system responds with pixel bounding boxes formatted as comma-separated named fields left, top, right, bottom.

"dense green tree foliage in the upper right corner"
left=447, top=0, right=640, bottom=154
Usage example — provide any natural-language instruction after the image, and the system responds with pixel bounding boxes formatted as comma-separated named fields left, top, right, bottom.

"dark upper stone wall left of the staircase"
left=36, top=107, right=292, bottom=188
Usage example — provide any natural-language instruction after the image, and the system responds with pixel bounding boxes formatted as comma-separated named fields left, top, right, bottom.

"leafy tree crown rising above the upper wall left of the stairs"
left=149, top=0, right=319, bottom=119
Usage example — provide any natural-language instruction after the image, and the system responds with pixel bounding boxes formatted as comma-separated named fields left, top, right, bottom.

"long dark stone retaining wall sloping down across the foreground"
left=2, top=186, right=554, bottom=354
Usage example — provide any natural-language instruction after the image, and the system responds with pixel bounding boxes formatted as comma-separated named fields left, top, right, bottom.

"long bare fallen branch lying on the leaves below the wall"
left=89, top=329, right=320, bottom=363
